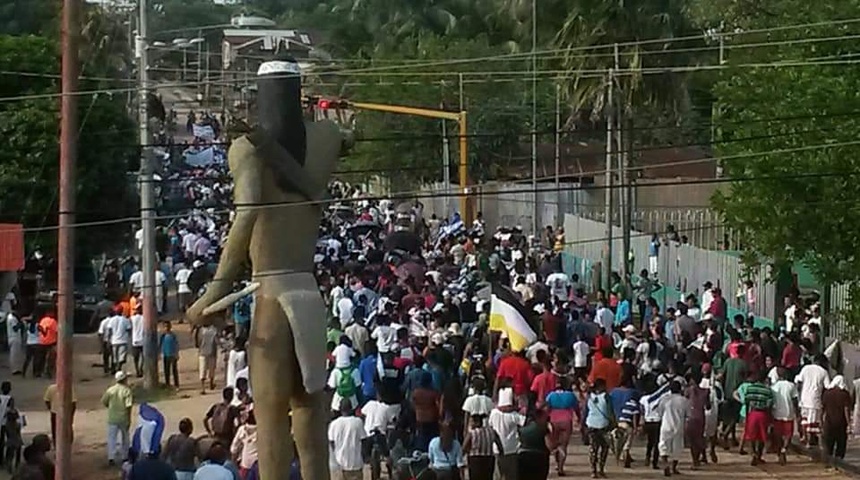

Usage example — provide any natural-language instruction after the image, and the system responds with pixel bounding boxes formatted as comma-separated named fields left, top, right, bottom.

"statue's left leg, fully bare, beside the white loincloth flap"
left=248, top=295, right=298, bottom=480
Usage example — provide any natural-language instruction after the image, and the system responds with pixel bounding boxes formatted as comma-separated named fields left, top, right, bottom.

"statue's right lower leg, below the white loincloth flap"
left=291, top=389, right=331, bottom=480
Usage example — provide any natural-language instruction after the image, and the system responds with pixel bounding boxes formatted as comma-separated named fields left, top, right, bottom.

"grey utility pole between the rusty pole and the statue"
left=137, top=0, right=160, bottom=389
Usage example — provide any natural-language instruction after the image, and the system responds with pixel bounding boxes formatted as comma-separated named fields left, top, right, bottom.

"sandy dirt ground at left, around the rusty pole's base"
left=0, top=323, right=215, bottom=480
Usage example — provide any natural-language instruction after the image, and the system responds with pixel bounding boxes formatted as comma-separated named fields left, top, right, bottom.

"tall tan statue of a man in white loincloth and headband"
left=187, top=60, right=342, bottom=480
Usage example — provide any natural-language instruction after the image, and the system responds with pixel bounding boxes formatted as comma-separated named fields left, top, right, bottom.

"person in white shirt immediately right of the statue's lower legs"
left=328, top=400, right=367, bottom=480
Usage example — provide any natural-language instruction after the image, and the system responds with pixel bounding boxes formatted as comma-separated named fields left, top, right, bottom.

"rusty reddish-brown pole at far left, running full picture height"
left=54, top=0, right=80, bottom=474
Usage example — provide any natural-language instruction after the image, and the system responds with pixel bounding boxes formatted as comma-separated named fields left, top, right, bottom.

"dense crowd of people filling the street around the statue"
left=101, top=180, right=858, bottom=480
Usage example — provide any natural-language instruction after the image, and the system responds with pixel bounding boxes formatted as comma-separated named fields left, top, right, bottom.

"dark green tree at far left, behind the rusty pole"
left=0, top=36, right=137, bottom=254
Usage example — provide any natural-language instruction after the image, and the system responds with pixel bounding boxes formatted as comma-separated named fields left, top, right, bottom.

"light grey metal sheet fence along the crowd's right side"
left=564, top=215, right=777, bottom=319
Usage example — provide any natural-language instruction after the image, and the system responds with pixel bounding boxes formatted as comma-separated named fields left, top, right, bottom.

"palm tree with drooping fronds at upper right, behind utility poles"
left=555, top=0, right=704, bottom=118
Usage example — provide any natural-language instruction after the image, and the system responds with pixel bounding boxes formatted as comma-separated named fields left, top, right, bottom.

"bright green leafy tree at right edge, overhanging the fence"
left=700, top=0, right=860, bottom=325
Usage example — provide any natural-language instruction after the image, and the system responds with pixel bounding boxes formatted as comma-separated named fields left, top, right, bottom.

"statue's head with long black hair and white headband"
left=257, top=50, right=307, bottom=165
